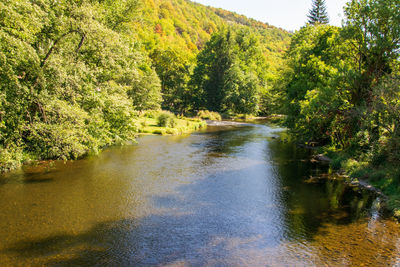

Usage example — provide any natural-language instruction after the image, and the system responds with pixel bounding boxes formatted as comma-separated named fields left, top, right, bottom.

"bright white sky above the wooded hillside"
left=193, top=0, right=348, bottom=31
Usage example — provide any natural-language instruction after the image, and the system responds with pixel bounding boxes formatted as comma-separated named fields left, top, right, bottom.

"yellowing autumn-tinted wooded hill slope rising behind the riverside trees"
left=136, top=0, right=291, bottom=71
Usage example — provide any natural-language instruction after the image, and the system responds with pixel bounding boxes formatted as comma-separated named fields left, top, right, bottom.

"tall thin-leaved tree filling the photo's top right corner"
left=343, top=0, right=400, bottom=106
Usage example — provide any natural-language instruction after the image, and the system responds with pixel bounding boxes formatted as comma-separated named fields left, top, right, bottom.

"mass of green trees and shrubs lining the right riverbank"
left=281, top=0, right=400, bottom=214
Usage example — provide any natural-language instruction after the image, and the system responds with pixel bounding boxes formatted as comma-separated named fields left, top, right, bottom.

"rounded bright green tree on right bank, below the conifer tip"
left=285, top=25, right=352, bottom=143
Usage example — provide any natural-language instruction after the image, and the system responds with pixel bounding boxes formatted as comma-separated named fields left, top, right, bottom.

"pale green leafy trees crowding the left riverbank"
left=0, top=0, right=161, bottom=171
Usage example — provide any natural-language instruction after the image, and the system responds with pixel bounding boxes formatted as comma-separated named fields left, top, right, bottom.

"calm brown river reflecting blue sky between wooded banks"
left=0, top=125, right=400, bottom=266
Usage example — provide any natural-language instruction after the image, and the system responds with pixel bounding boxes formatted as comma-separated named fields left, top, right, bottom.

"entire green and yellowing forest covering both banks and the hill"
left=0, top=0, right=400, bottom=213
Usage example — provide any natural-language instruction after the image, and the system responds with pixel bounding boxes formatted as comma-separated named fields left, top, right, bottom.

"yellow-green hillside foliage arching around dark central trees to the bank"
left=134, top=0, right=290, bottom=114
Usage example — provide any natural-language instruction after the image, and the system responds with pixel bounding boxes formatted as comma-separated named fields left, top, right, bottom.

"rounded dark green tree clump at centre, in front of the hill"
left=192, top=28, right=267, bottom=114
